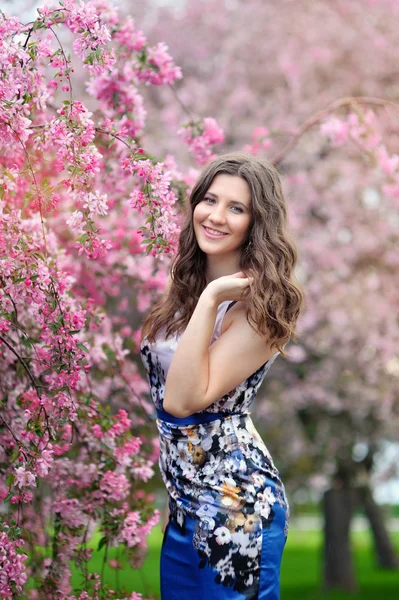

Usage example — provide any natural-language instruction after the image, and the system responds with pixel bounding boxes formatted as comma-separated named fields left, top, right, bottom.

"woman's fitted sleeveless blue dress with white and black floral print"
left=141, top=301, right=289, bottom=600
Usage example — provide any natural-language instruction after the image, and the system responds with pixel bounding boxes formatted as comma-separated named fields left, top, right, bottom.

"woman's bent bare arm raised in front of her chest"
left=164, top=278, right=273, bottom=417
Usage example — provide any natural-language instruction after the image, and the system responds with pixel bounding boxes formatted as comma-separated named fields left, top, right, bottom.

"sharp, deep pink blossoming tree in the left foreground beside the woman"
left=0, top=0, right=222, bottom=600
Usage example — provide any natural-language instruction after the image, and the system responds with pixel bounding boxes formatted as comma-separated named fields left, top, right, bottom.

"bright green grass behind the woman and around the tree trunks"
left=67, top=527, right=399, bottom=600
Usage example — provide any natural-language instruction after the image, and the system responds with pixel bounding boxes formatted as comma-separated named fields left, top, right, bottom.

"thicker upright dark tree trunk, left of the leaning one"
left=323, top=488, right=356, bottom=592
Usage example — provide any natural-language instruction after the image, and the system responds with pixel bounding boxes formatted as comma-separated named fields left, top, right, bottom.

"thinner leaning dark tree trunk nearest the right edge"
left=359, top=486, right=399, bottom=569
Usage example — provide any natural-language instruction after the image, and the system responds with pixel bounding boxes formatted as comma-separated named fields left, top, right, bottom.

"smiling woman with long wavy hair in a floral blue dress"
left=141, top=153, right=302, bottom=600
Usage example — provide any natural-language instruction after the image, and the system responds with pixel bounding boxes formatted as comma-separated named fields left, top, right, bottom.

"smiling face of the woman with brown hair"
left=193, top=173, right=252, bottom=255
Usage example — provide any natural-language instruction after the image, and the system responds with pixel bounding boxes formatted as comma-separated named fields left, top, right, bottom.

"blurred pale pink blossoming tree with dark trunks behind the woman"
left=127, top=0, right=399, bottom=589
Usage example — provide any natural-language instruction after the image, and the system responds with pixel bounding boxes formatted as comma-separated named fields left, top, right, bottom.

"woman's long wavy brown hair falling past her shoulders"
left=142, top=152, right=303, bottom=356
